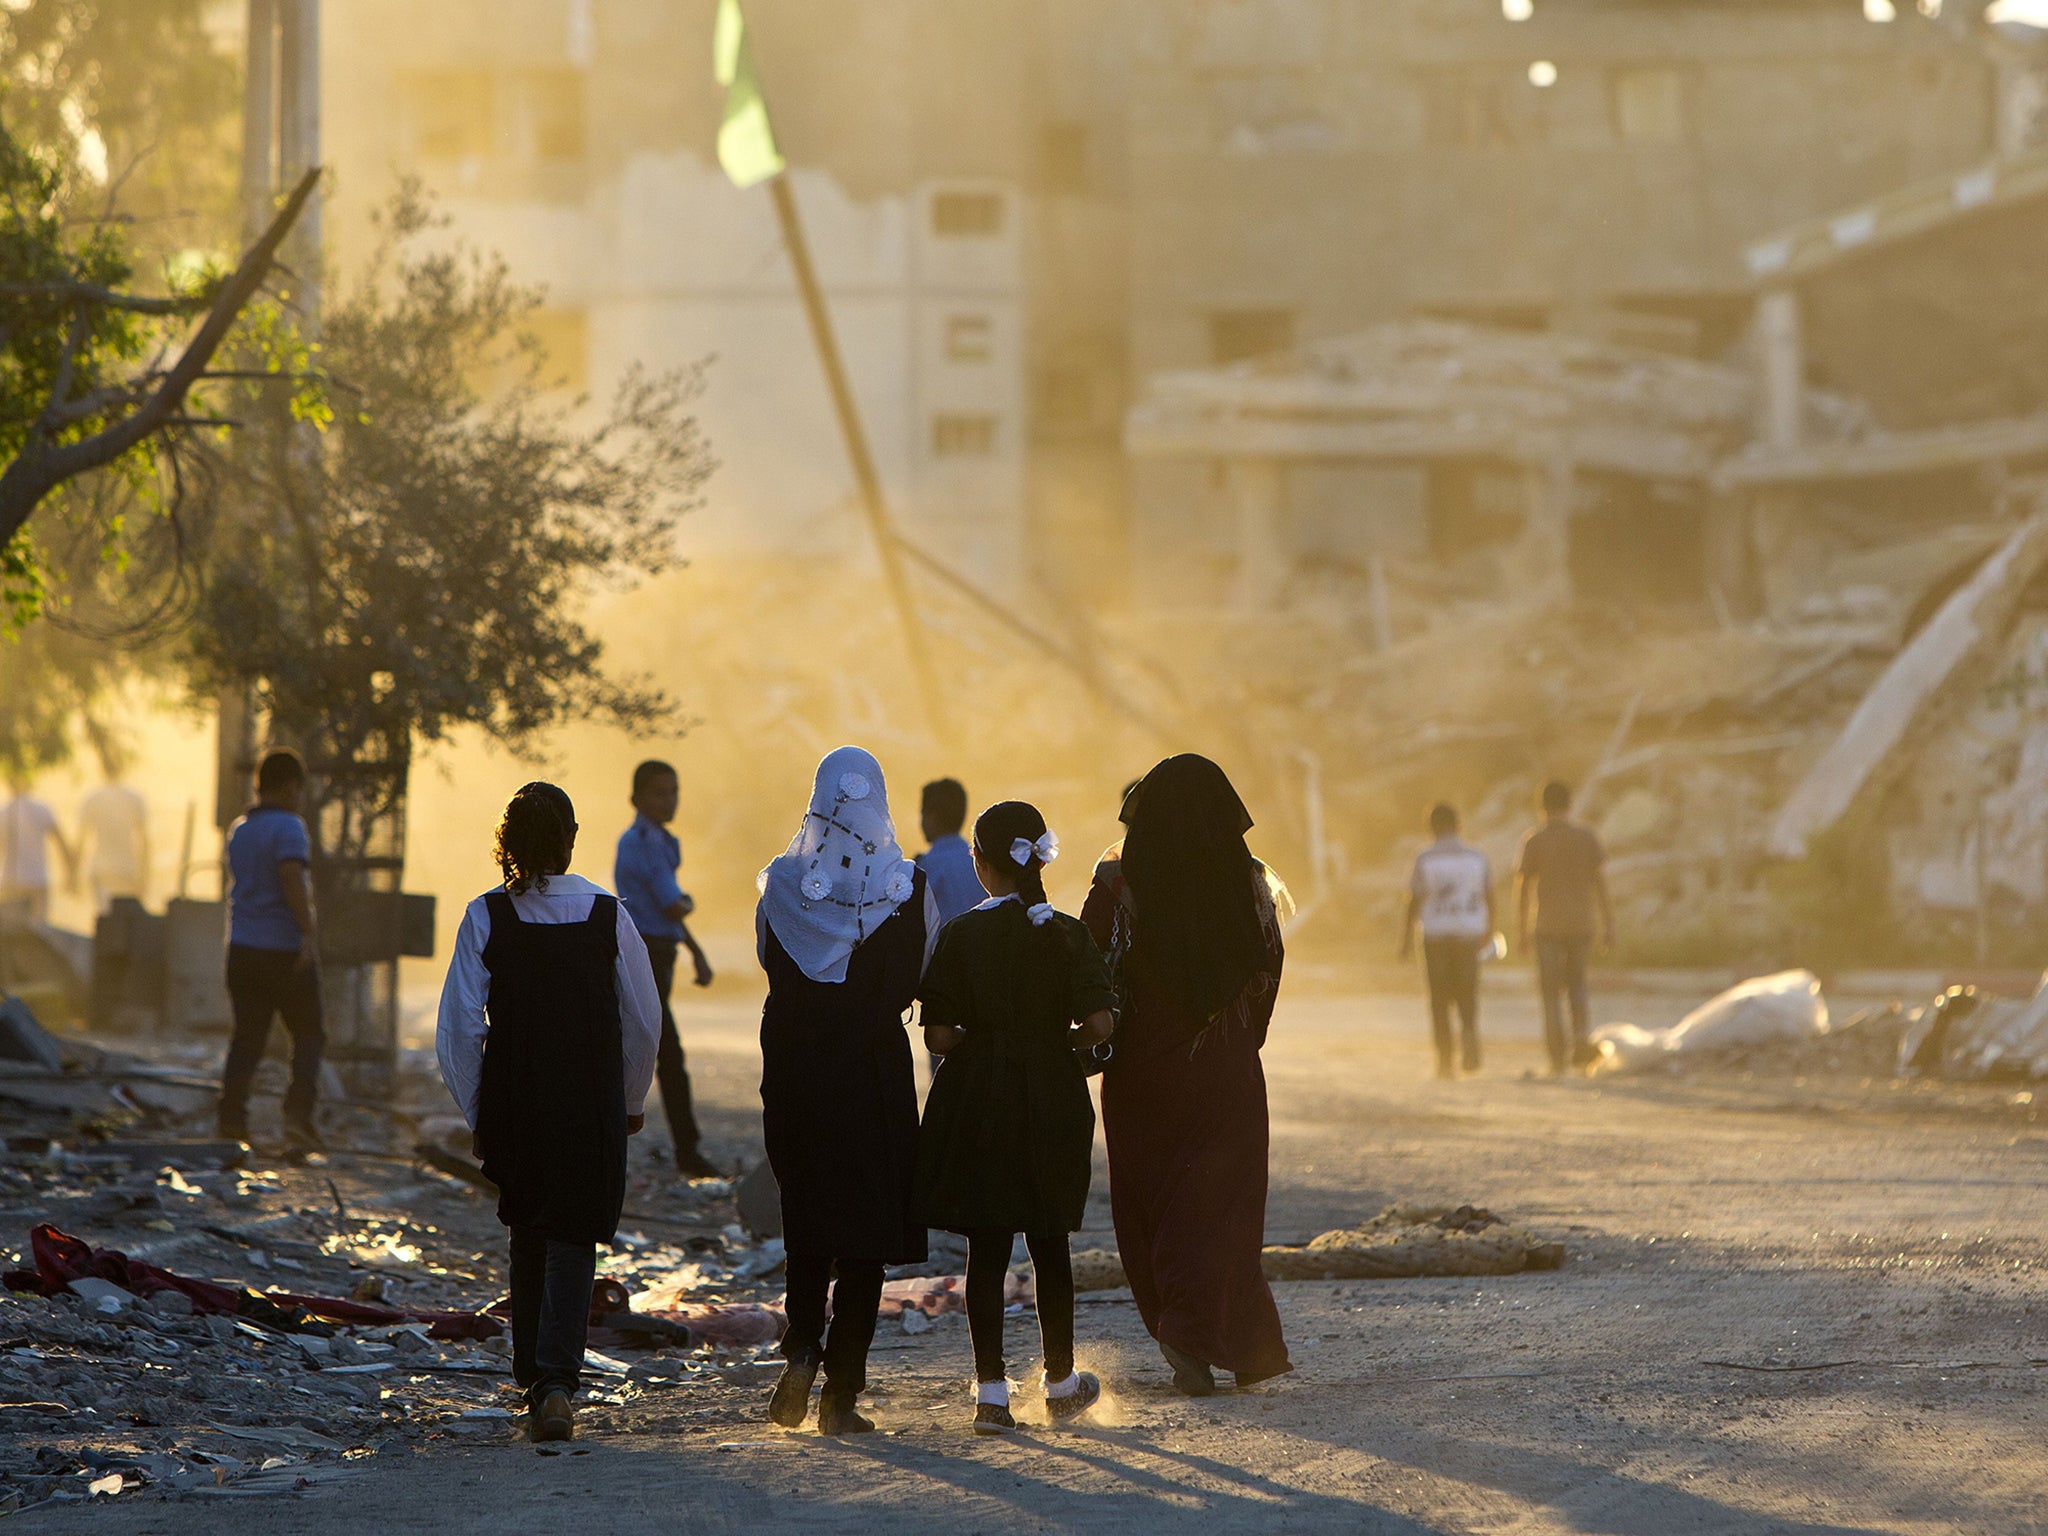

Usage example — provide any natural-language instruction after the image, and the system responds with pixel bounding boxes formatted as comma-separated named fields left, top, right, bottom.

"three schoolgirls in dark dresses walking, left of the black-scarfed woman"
left=438, top=748, right=1114, bottom=1440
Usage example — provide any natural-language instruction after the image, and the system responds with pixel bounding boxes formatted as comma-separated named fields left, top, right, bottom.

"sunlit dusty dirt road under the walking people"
left=20, top=987, right=2048, bottom=1536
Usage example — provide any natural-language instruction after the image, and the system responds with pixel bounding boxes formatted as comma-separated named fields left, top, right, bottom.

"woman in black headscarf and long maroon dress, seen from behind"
left=1081, top=754, right=1294, bottom=1397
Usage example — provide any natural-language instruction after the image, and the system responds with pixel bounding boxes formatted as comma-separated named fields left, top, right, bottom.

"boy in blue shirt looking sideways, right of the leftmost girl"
left=612, top=760, right=725, bottom=1180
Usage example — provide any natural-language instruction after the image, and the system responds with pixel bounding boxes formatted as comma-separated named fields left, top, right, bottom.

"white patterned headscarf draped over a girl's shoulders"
left=760, top=748, right=915, bottom=981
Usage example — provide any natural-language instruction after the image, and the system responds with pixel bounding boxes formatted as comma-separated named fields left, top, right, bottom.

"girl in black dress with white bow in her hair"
left=918, top=801, right=1116, bottom=1436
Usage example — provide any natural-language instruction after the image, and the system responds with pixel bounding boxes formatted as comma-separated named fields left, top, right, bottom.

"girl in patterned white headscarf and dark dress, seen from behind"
left=754, top=748, right=938, bottom=1434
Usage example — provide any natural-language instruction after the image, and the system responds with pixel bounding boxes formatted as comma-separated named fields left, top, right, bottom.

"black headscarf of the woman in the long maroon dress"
left=1120, top=752, right=1266, bottom=1024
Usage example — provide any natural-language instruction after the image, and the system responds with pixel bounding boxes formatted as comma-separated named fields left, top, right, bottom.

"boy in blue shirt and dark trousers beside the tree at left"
left=219, top=752, right=328, bottom=1151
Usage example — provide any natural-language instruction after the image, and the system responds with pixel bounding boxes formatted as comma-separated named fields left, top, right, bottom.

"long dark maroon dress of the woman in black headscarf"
left=1081, top=864, right=1292, bottom=1376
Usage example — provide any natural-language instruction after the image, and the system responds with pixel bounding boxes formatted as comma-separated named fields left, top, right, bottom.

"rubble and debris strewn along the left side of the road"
left=0, top=1114, right=798, bottom=1511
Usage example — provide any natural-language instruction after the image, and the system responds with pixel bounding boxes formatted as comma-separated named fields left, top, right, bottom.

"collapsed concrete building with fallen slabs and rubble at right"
left=1126, top=150, right=2048, bottom=961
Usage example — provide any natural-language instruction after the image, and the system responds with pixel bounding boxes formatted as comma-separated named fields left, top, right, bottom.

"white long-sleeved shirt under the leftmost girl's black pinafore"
left=434, top=874, right=662, bottom=1130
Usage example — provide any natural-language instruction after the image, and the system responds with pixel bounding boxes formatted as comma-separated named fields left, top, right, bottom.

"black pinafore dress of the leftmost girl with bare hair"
left=477, top=891, right=627, bottom=1243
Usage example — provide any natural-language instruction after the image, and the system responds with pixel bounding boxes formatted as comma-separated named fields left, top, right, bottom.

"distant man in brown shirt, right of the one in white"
left=1516, top=780, right=1614, bottom=1075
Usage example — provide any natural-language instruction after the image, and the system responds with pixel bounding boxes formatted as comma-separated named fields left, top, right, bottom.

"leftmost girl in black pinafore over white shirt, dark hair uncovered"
left=436, top=782, right=662, bottom=1440
